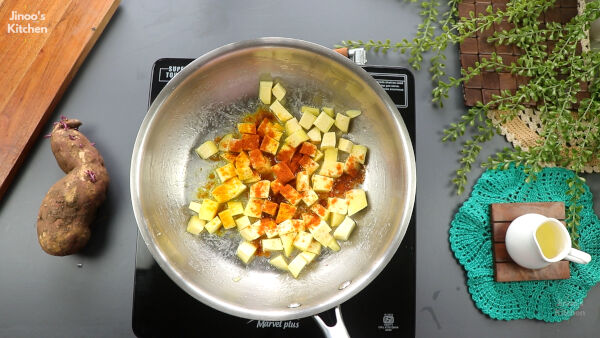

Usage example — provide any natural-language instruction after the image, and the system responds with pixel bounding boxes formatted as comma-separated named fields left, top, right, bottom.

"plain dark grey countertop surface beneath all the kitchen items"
left=0, top=0, right=600, bottom=337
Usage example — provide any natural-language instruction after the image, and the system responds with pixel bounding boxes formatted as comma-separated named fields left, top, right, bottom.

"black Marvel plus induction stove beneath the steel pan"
left=132, top=58, right=416, bottom=338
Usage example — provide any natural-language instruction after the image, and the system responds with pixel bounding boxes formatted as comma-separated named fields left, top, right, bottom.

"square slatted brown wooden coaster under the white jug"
left=490, top=202, right=571, bottom=282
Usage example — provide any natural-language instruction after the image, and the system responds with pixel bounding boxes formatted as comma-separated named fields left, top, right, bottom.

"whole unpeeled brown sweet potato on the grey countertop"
left=37, top=117, right=109, bottom=256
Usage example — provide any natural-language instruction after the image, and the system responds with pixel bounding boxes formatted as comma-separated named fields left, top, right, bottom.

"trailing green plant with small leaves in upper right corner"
left=342, top=0, right=600, bottom=246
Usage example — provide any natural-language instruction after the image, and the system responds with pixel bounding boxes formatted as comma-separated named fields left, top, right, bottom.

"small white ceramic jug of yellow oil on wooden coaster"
left=505, top=214, right=592, bottom=269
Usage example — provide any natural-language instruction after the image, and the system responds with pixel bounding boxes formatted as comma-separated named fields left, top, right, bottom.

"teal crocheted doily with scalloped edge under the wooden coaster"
left=450, top=167, right=600, bottom=322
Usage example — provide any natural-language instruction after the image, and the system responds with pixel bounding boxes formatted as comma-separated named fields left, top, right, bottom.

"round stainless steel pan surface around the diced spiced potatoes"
left=130, top=38, right=415, bottom=332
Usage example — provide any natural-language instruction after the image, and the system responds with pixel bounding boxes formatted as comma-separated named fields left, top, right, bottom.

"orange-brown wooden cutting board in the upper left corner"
left=0, top=0, right=120, bottom=199
